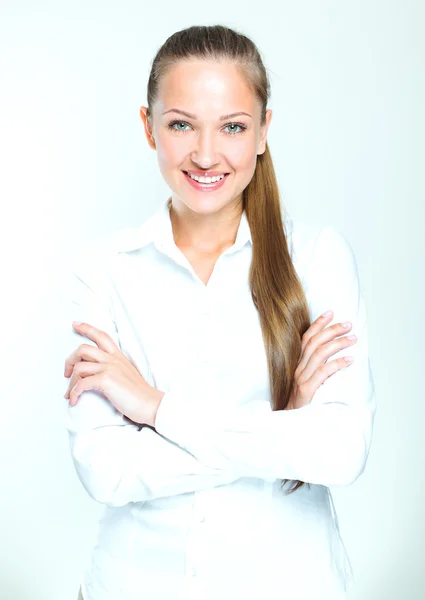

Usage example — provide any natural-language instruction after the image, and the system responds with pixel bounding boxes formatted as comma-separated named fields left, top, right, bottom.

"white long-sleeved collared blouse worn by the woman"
left=64, top=199, right=376, bottom=600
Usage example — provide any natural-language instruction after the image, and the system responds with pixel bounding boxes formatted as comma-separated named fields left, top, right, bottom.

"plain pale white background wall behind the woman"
left=0, top=0, right=425, bottom=600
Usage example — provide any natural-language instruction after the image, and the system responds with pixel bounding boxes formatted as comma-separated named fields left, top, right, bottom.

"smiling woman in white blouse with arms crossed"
left=65, top=25, right=376, bottom=600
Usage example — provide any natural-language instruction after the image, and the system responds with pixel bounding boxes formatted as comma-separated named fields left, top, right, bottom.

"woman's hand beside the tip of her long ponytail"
left=285, top=313, right=357, bottom=410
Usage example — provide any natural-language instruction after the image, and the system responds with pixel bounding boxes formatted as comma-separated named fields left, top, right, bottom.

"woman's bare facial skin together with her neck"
left=140, top=56, right=268, bottom=232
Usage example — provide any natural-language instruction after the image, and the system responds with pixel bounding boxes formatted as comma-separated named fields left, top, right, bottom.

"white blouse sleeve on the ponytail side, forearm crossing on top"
left=155, top=226, right=376, bottom=486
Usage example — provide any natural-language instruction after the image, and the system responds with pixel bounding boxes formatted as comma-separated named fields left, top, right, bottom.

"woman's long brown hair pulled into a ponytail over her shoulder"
left=147, top=25, right=311, bottom=493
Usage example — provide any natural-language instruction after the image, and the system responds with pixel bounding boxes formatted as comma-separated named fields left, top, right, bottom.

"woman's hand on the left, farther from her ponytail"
left=64, top=323, right=164, bottom=427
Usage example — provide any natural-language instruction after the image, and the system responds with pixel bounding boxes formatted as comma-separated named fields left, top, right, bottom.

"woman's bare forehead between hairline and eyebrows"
left=156, top=59, right=258, bottom=118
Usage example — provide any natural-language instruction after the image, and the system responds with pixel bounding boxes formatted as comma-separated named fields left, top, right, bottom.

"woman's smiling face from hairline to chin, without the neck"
left=140, top=60, right=272, bottom=214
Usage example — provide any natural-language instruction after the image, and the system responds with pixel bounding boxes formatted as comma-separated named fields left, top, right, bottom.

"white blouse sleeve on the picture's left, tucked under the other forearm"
left=62, top=240, right=247, bottom=506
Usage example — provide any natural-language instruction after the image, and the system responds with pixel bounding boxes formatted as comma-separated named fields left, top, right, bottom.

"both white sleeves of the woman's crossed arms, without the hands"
left=65, top=227, right=376, bottom=506
